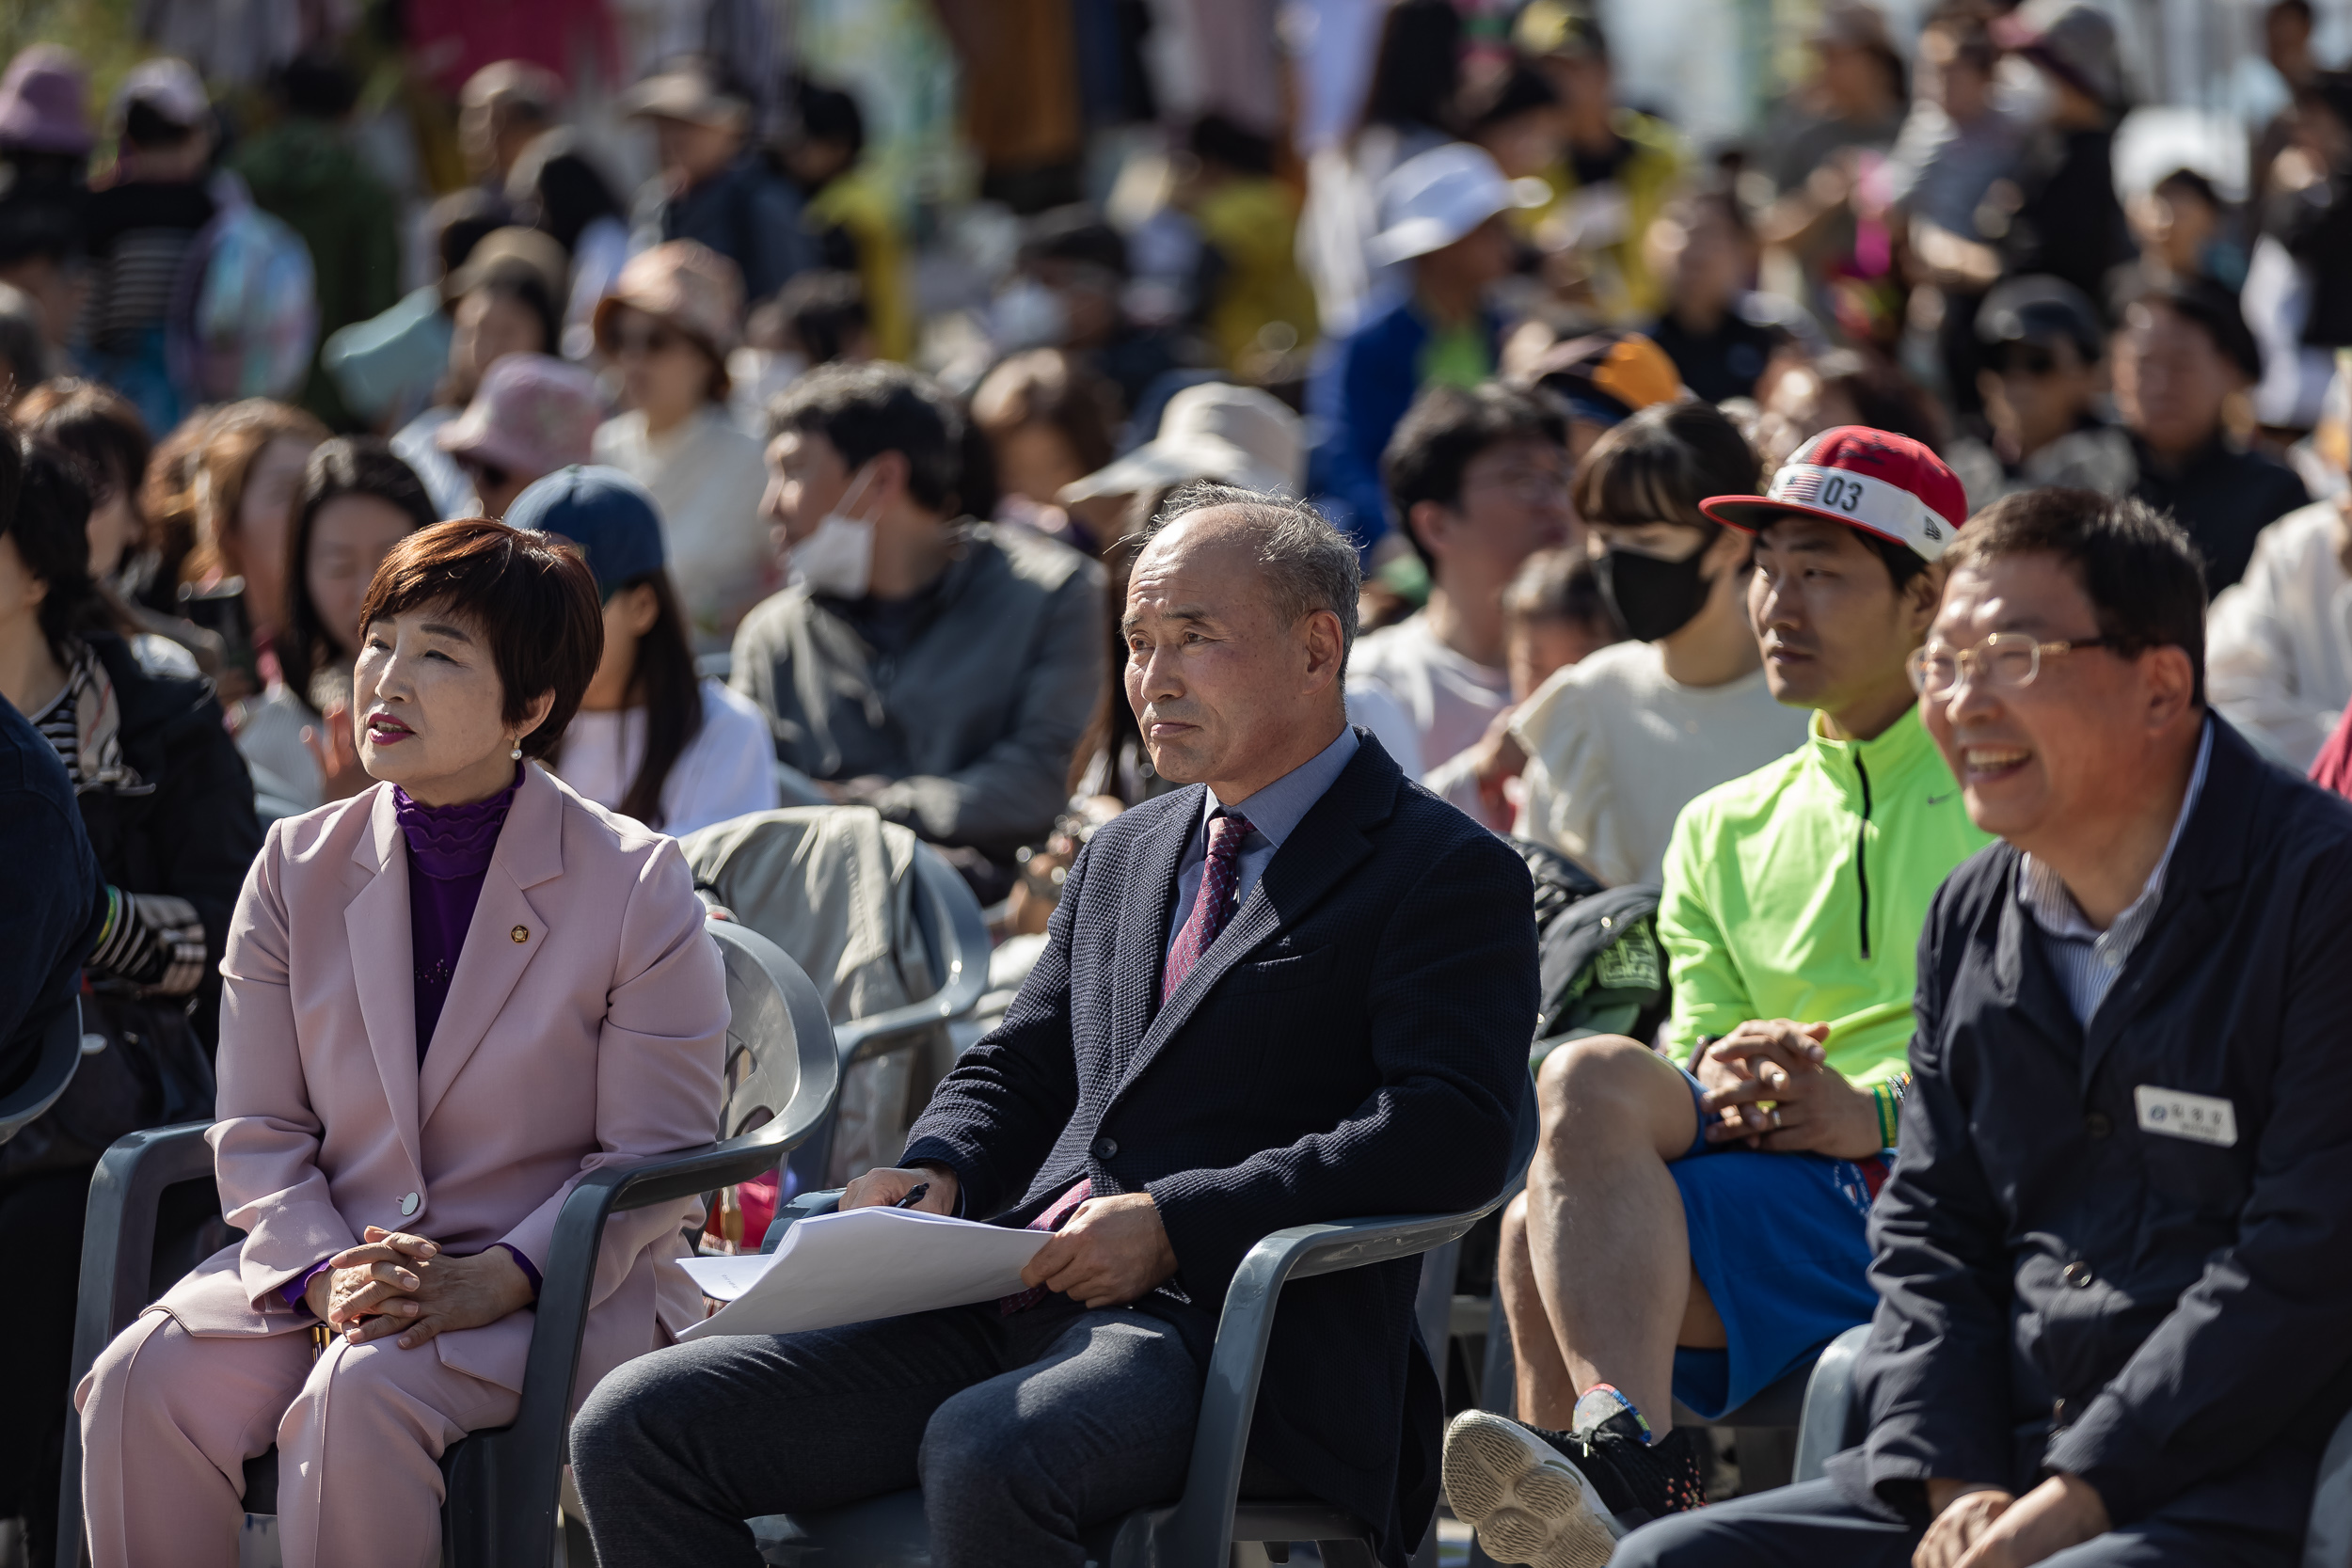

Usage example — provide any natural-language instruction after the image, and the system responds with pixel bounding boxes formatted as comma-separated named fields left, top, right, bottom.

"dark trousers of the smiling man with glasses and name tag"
left=1609, top=1481, right=2303, bottom=1568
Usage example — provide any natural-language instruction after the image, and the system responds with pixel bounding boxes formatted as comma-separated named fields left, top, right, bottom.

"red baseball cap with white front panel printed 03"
left=1698, top=425, right=1969, bottom=560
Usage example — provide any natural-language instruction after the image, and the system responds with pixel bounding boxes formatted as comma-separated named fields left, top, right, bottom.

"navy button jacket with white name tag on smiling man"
left=1833, top=717, right=2352, bottom=1528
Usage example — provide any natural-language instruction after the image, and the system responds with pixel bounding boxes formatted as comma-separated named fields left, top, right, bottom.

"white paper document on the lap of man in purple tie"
left=677, top=1209, right=1047, bottom=1340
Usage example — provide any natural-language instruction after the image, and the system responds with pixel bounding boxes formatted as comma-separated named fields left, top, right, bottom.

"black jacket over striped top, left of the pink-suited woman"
left=80, top=632, right=262, bottom=1051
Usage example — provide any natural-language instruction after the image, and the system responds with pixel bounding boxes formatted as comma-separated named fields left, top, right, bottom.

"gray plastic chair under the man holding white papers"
left=753, top=1192, right=1503, bottom=1568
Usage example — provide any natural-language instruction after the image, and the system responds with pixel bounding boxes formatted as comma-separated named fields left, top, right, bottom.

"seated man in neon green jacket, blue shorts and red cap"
left=1447, top=425, right=1990, bottom=1568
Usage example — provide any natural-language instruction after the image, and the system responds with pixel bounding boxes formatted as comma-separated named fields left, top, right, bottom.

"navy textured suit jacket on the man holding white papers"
left=903, top=731, right=1536, bottom=1563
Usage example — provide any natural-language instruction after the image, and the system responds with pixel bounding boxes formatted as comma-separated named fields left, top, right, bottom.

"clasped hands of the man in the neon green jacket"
left=1696, top=1018, right=1886, bottom=1159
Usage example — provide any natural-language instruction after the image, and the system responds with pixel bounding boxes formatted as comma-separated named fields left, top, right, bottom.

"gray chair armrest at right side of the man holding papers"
left=1165, top=1195, right=1503, bottom=1563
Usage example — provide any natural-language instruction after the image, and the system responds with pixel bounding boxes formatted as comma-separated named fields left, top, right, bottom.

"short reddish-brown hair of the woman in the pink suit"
left=360, top=517, right=605, bottom=757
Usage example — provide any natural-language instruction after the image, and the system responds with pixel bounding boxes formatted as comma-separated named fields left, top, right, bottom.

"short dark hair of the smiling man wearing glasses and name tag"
left=1943, top=484, right=2206, bottom=707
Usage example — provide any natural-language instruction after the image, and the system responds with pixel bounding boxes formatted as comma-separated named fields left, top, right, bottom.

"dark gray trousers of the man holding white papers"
left=572, top=1295, right=1202, bottom=1568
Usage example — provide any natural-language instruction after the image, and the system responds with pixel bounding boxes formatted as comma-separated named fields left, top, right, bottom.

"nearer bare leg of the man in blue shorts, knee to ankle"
left=1527, top=1037, right=1720, bottom=1434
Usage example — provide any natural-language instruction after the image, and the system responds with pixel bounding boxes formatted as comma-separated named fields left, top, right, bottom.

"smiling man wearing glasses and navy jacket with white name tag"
left=1616, top=489, right=2352, bottom=1568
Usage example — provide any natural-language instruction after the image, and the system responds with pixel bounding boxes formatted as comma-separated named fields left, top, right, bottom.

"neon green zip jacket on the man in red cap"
left=1659, top=710, right=1993, bottom=1084
